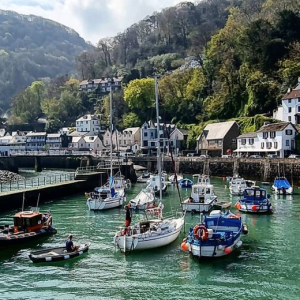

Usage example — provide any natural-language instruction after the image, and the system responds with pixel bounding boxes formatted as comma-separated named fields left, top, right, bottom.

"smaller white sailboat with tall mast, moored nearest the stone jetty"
left=86, top=79, right=126, bottom=210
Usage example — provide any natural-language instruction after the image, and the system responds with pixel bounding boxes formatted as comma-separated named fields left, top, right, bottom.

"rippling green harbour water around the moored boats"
left=0, top=178, right=300, bottom=300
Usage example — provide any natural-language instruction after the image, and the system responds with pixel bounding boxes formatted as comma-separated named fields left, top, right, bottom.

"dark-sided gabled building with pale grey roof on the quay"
left=196, top=121, right=240, bottom=157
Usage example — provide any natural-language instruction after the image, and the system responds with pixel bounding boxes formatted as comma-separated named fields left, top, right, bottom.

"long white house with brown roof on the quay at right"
left=235, top=122, right=298, bottom=158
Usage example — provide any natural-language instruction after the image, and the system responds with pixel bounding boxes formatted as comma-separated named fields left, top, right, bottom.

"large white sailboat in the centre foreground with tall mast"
left=114, top=78, right=185, bottom=253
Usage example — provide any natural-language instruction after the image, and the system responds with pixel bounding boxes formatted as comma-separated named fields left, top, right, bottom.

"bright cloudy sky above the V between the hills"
left=0, top=0, right=190, bottom=44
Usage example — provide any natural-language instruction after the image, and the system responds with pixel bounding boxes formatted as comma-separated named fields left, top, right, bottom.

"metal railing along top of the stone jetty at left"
left=0, top=173, right=75, bottom=193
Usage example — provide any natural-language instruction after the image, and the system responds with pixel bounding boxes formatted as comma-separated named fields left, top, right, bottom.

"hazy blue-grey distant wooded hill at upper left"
left=0, top=10, right=93, bottom=114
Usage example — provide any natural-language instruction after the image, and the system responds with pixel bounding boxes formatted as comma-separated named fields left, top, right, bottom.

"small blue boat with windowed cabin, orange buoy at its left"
left=235, top=186, right=272, bottom=213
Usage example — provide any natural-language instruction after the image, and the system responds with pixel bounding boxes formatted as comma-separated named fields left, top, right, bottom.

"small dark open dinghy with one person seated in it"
left=29, top=244, right=89, bottom=263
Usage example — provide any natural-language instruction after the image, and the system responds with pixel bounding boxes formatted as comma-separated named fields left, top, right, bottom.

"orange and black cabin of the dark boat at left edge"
left=14, top=211, right=44, bottom=233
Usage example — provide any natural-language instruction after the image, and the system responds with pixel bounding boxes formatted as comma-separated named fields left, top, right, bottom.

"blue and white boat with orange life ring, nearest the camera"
left=181, top=210, right=248, bottom=258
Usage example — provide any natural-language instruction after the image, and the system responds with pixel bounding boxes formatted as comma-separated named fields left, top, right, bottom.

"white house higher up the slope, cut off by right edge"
left=273, top=78, right=300, bottom=124
